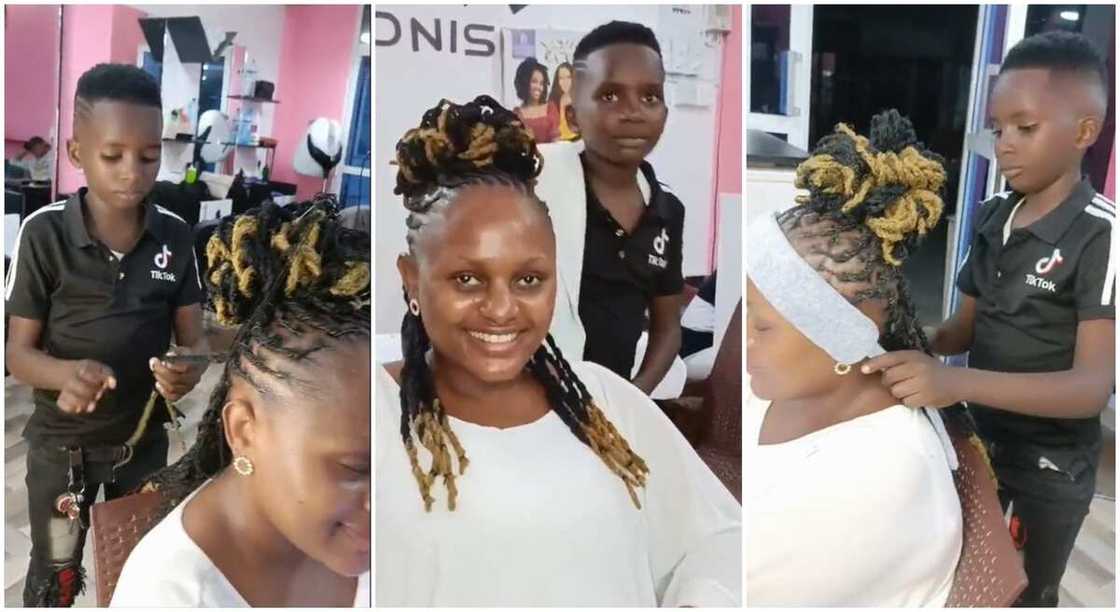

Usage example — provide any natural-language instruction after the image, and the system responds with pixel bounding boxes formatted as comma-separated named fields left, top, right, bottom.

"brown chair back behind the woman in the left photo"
left=90, top=491, right=164, bottom=608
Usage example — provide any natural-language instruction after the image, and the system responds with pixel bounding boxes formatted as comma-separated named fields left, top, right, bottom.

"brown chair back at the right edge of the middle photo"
left=696, top=299, right=743, bottom=501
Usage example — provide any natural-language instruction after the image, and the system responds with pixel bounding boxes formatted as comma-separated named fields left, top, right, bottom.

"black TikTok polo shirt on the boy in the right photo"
left=956, top=180, right=1116, bottom=446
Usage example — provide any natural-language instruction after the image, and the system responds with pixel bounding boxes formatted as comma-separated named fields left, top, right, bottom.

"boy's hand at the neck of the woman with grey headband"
left=860, top=351, right=963, bottom=408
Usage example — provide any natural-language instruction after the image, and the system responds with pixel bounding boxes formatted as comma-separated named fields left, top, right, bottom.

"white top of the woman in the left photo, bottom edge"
left=110, top=484, right=370, bottom=608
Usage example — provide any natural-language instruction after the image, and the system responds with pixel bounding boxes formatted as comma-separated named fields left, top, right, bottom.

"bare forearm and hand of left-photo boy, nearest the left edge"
left=4, top=315, right=116, bottom=414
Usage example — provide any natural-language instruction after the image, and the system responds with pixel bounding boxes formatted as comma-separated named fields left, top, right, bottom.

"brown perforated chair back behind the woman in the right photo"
left=945, top=432, right=1027, bottom=608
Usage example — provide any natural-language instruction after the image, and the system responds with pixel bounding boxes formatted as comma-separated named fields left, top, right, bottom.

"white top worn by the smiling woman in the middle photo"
left=374, top=362, right=743, bottom=608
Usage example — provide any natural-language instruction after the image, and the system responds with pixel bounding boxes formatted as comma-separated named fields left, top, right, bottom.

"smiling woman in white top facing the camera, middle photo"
left=374, top=96, right=741, bottom=606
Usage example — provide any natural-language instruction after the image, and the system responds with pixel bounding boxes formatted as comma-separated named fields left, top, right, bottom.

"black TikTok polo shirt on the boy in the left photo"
left=4, top=188, right=202, bottom=445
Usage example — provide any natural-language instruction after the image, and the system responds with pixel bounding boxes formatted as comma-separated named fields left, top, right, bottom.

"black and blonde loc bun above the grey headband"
left=795, top=110, right=945, bottom=266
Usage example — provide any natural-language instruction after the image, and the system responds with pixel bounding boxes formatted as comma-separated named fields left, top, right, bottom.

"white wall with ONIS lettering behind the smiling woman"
left=373, top=4, right=720, bottom=333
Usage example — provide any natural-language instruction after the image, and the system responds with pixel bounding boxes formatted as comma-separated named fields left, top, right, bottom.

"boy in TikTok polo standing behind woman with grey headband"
left=864, top=31, right=1117, bottom=606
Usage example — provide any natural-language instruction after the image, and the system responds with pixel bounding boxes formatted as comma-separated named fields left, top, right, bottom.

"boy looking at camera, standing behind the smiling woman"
left=542, top=21, right=684, bottom=393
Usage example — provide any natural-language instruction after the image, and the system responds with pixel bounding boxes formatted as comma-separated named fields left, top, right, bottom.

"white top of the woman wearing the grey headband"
left=743, top=381, right=962, bottom=608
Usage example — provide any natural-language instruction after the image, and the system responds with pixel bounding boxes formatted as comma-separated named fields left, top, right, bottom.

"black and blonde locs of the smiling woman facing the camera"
left=394, top=95, right=648, bottom=511
